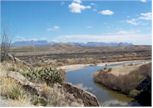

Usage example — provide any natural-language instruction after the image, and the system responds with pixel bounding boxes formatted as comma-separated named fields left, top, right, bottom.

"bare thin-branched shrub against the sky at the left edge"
left=1, top=31, right=11, bottom=62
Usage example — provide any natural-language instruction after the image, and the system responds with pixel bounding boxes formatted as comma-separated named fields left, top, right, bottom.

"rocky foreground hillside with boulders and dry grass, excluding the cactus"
left=0, top=57, right=99, bottom=107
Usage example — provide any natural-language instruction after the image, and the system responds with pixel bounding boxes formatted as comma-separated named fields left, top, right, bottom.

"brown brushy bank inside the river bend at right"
left=94, top=63, right=151, bottom=105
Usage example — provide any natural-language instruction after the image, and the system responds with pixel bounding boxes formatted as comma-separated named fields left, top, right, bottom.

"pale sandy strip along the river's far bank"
left=57, top=60, right=151, bottom=72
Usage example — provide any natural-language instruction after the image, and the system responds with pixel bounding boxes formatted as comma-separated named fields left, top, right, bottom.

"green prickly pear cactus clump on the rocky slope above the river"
left=24, top=67, right=64, bottom=85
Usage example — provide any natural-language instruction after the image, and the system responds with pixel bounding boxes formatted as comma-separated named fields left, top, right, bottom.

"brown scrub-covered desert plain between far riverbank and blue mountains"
left=11, top=43, right=151, bottom=66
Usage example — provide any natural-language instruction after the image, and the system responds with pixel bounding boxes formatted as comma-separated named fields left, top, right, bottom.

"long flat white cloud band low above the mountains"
left=54, top=33, right=151, bottom=44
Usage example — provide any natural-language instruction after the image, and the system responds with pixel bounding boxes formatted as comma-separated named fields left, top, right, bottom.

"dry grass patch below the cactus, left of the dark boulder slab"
left=32, top=84, right=83, bottom=106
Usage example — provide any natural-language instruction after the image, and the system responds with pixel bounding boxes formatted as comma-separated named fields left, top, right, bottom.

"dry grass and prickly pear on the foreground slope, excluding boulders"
left=0, top=61, right=84, bottom=106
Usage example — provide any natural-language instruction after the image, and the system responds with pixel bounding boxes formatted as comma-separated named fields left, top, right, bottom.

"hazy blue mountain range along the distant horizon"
left=13, top=40, right=133, bottom=47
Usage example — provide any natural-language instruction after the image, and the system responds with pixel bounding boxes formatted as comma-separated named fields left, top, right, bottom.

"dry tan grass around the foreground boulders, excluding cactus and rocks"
left=0, top=62, right=83, bottom=106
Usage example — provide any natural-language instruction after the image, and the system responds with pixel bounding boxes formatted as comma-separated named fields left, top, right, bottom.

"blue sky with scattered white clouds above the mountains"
left=1, top=0, right=152, bottom=45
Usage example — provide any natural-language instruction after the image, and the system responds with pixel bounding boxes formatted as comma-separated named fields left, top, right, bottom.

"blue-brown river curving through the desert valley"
left=66, top=61, right=149, bottom=106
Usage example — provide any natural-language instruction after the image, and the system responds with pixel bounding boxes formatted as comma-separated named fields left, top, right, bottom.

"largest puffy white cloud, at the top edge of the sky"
left=69, top=0, right=91, bottom=13
